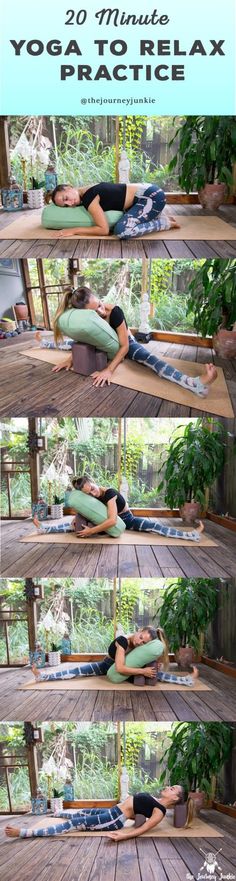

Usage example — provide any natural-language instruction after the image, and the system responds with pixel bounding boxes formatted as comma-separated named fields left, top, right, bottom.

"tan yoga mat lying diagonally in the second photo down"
left=19, top=341, right=234, bottom=419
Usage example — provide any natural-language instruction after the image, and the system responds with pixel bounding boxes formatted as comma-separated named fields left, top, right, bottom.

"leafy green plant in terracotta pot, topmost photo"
left=169, top=116, right=236, bottom=211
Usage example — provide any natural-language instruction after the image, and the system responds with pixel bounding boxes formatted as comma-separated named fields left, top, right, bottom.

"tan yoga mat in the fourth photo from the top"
left=21, top=664, right=212, bottom=692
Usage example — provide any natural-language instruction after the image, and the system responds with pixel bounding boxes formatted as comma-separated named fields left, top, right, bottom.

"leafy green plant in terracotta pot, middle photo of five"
left=157, top=418, right=227, bottom=526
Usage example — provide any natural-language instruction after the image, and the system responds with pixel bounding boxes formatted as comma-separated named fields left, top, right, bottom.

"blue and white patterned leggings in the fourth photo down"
left=37, top=658, right=193, bottom=687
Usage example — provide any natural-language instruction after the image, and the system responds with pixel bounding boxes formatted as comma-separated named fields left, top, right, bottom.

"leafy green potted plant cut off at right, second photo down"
left=188, top=258, right=236, bottom=358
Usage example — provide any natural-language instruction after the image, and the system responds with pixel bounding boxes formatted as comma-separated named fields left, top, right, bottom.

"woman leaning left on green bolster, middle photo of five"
left=33, top=474, right=204, bottom=541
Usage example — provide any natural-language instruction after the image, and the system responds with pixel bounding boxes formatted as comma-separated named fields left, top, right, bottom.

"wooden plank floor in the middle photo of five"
left=1, top=520, right=236, bottom=579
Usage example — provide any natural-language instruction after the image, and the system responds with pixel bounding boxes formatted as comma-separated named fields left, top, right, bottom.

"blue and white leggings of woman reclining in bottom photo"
left=20, top=805, right=127, bottom=838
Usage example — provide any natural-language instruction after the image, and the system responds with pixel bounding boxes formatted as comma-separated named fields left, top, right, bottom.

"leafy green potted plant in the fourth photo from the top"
left=159, top=578, right=217, bottom=670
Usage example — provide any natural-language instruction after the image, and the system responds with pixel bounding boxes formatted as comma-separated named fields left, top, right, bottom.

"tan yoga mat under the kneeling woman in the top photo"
left=0, top=206, right=236, bottom=242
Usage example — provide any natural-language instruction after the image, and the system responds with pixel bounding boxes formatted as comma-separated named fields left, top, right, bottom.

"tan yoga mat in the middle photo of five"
left=20, top=523, right=217, bottom=548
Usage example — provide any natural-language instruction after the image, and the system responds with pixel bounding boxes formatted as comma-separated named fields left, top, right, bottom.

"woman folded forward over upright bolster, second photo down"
left=36, top=287, right=217, bottom=398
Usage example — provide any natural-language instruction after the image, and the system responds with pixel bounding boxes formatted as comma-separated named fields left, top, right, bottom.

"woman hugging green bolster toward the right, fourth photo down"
left=31, top=627, right=198, bottom=685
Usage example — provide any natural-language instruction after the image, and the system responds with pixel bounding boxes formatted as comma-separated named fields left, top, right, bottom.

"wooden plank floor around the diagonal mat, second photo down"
left=0, top=332, right=236, bottom=418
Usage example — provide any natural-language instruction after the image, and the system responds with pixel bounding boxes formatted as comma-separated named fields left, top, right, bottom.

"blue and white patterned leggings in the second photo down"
left=41, top=334, right=208, bottom=398
